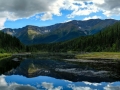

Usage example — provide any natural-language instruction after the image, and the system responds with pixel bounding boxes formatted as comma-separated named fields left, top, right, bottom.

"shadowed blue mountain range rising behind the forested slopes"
left=2, top=19, right=117, bottom=44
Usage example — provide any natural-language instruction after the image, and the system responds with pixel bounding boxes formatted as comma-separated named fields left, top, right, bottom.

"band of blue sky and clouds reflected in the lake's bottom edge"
left=0, top=75, right=120, bottom=90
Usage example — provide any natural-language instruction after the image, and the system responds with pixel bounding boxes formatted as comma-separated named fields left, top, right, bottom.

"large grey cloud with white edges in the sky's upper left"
left=0, top=0, right=64, bottom=28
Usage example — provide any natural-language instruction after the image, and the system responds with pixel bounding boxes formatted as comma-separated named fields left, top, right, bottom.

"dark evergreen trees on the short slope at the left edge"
left=0, top=31, right=25, bottom=53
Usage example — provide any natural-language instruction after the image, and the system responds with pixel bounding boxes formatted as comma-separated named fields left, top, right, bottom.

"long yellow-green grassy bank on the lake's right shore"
left=75, top=52, right=120, bottom=59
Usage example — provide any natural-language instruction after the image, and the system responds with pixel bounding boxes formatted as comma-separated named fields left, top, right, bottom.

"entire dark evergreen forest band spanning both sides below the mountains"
left=0, top=22, right=120, bottom=53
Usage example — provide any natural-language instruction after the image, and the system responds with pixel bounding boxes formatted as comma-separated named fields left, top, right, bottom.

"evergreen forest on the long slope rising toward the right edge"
left=27, top=22, right=120, bottom=52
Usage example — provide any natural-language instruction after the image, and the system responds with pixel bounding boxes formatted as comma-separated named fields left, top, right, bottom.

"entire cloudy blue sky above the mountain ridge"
left=0, top=0, right=120, bottom=29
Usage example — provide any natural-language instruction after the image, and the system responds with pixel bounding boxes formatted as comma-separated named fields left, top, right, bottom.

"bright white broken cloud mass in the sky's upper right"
left=65, top=0, right=120, bottom=18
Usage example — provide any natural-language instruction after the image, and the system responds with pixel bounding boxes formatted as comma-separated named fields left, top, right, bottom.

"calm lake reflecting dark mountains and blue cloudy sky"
left=0, top=53, right=120, bottom=90
